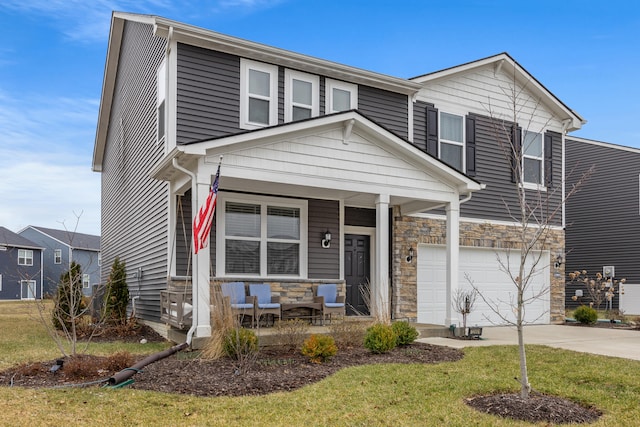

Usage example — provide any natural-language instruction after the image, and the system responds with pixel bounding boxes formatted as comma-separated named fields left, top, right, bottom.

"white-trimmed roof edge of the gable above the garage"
left=410, top=52, right=587, bottom=132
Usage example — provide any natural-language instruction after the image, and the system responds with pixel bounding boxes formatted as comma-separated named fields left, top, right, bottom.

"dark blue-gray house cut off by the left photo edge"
left=0, top=227, right=43, bottom=300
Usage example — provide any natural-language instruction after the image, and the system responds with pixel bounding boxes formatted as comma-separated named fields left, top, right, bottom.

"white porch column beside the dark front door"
left=371, top=194, right=390, bottom=319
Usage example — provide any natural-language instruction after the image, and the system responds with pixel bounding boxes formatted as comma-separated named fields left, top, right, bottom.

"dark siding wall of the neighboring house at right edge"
left=565, top=137, right=640, bottom=306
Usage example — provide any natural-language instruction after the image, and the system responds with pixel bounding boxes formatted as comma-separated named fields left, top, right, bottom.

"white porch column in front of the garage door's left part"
left=445, top=200, right=460, bottom=326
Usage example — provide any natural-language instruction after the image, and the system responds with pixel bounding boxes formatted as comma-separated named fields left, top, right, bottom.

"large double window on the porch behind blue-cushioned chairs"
left=218, top=198, right=307, bottom=277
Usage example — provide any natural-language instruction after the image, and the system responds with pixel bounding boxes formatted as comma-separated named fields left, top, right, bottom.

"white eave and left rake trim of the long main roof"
left=93, top=12, right=421, bottom=172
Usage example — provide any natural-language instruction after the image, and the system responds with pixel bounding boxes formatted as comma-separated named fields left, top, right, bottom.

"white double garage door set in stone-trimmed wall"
left=417, top=245, right=550, bottom=326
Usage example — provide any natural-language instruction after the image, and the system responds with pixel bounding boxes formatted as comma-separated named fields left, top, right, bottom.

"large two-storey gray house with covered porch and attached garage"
left=93, top=12, right=584, bottom=337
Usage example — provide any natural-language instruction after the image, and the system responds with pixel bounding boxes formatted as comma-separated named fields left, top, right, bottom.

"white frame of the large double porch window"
left=216, top=193, right=308, bottom=279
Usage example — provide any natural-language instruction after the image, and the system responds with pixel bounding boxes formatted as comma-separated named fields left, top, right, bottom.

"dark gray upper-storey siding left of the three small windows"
left=176, top=44, right=240, bottom=144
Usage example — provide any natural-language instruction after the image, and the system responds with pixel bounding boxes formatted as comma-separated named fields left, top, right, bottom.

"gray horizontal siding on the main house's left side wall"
left=101, top=22, right=168, bottom=321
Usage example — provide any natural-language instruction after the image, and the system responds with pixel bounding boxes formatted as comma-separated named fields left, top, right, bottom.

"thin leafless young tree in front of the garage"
left=470, top=68, right=593, bottom=398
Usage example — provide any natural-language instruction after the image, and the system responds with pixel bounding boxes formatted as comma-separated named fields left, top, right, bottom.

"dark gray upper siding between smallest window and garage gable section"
left=358, top=85, right=409, bottom=139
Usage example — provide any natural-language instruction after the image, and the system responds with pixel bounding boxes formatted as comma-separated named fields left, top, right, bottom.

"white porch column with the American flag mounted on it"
left=192, top=173, right=215, bottom=337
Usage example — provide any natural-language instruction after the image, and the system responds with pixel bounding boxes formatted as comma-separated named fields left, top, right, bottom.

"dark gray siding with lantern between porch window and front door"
left=308, top=199, right=342, bottom=279
